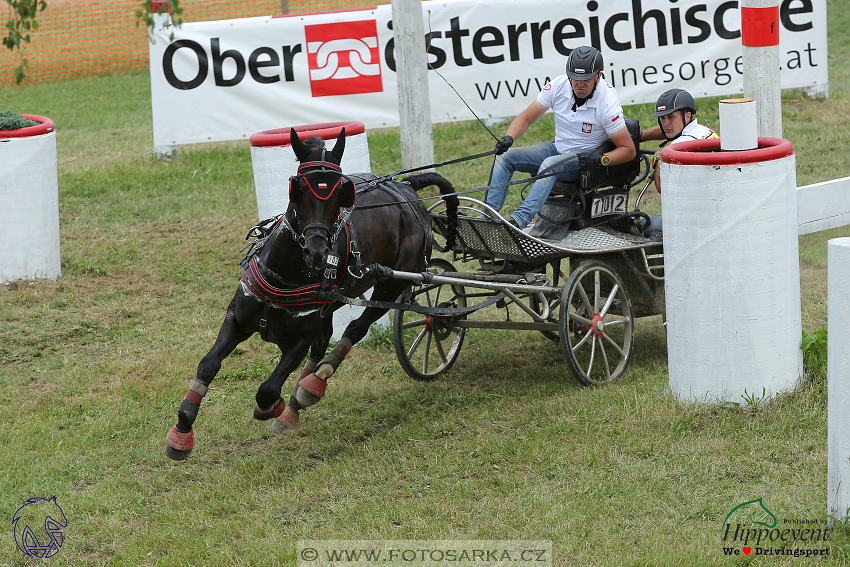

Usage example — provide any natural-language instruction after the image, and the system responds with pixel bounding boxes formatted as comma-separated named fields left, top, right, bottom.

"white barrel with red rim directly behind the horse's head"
left=251, top=122, right=372, bottom=221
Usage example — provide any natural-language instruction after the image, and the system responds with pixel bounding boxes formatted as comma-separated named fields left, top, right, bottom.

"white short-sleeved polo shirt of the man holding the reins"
left=537, top=75, right=626, bottom=154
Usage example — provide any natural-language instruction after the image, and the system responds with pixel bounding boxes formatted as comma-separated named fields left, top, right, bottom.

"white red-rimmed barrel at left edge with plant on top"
left=0, top=114, right=62, bottom=283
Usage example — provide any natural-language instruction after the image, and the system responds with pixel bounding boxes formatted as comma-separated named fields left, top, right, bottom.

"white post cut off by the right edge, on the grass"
left=827, top=238, right=850, bottom=522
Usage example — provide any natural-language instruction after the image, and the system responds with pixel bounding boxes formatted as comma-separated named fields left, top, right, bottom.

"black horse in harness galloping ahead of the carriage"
left=165, top=129, right=457, bottom=460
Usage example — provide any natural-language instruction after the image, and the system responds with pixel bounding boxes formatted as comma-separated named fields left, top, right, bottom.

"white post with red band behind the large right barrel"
left=741, top=0, right=782, bottom=138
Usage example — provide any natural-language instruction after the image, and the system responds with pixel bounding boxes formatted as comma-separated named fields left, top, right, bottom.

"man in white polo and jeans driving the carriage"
left=486, top=46, right=635, bottom=228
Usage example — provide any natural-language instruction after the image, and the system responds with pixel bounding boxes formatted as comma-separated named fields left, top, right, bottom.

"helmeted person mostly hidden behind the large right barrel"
left=640, top=89, right=718, bottom=234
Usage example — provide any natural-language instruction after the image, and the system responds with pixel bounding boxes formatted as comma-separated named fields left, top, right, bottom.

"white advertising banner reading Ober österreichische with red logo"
left=150, top=0, right=828, bottom=146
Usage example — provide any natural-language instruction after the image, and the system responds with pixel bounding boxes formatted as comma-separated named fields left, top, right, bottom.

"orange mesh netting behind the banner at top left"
left=0, top=0, right=389, bottom=87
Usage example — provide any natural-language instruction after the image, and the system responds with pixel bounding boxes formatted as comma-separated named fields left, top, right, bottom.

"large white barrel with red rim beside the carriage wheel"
left=660, top=138, right=803, bottom=403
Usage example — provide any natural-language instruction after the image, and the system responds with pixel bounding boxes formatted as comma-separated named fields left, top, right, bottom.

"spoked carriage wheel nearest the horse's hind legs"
left=393, top=258, right=466, bottom=380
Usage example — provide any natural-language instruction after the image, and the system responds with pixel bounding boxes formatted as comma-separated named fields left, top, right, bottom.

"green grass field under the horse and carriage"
left=0, top=0, right=850, bottom=567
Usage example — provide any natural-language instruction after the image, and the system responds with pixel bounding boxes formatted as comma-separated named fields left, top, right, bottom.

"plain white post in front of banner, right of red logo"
left=392, top=0, right=434, bottom=172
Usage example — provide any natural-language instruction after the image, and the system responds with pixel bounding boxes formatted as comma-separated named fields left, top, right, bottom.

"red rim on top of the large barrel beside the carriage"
left=661, top=137, right=794, bottom=165
